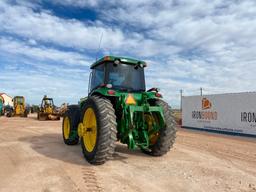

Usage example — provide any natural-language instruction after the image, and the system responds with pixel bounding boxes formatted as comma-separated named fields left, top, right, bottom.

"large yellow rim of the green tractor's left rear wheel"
left=83, top=108, right=97, bottom=152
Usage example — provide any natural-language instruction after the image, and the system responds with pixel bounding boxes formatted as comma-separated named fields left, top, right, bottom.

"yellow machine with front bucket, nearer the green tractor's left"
left=37, top=95, right=60, bottom=121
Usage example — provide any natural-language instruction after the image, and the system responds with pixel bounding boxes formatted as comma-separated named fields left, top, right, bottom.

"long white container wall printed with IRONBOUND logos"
left=182, top=92, right=256, bottom=136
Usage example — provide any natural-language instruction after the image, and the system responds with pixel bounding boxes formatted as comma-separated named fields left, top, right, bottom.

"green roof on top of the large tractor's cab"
left=90, top=55, right=147, bottom=69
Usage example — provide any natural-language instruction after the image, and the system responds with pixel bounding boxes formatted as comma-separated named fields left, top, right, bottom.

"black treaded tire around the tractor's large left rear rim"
left=80, top=96, right=117, bottom=165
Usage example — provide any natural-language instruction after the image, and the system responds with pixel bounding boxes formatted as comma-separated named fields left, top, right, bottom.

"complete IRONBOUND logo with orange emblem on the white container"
left=192, top=98, right=218, bottom=121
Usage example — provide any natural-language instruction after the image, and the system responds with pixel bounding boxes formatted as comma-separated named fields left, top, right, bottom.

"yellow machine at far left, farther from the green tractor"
left=6, top=96, right=28, bottom=117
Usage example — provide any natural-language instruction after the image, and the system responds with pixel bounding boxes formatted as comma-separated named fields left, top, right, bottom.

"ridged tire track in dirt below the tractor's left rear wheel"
left=82, top=167, right=103, bottom=192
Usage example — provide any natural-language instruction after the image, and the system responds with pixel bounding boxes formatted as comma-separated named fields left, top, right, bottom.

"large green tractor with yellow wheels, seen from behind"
left=62, top=56, right=176, bottom=165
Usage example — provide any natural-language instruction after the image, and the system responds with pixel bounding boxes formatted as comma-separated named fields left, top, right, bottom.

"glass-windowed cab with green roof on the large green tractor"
left=89, top=56, right=146, bottom=92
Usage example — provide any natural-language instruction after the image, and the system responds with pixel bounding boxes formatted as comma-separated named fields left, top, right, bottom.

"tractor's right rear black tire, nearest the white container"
left=142, top=100, right=177, bottom=156
